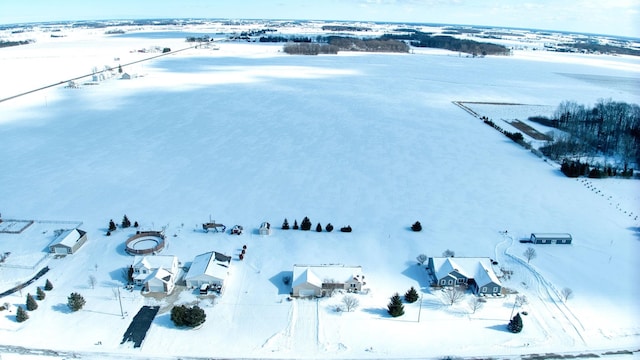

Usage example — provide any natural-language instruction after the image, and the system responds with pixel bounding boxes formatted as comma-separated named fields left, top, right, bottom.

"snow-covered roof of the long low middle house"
left=293, top=264, right=363, bottom=286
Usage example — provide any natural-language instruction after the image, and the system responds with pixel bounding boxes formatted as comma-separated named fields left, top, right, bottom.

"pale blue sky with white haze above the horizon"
left=0, top=0, right=640, bottom=37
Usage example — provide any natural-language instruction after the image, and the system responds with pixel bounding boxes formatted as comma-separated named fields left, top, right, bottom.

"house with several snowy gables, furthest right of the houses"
left=427, top=257, right=502, bottom=295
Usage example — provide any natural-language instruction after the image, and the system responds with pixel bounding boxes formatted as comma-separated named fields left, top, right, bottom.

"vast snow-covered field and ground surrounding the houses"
left=0, top=23, right=640, bottom=359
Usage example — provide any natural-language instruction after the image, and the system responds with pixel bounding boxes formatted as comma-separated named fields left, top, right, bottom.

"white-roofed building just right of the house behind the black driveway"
left=185, top=251, right=231, bottom=292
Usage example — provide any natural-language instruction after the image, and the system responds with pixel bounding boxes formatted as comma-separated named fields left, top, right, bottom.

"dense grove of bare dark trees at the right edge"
left=529, top=100, right=640, bottom=176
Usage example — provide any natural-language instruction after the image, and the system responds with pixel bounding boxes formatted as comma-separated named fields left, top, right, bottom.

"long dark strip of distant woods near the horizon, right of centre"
left=381, top=29, right=511, bottom=56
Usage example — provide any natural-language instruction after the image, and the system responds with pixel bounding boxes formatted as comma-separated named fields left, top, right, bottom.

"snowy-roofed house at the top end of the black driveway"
left=133, top=255, right=179, bottom=294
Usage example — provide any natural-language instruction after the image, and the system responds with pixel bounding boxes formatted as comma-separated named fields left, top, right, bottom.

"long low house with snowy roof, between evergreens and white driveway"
left=291, top=264, right=366, bottom=297
